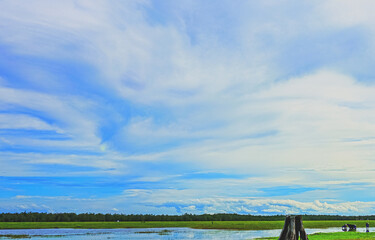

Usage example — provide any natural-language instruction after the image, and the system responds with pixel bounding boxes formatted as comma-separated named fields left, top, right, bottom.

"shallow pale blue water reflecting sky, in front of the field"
left=0, top=228, right=372, bottom=240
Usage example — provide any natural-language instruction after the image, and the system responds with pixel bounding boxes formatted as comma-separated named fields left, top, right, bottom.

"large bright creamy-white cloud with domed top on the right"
left=128, top=71, right=375, bottom=175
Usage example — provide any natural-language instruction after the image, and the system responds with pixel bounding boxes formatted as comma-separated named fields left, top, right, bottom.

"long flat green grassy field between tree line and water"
left=0, top=220, right=375, bottom=230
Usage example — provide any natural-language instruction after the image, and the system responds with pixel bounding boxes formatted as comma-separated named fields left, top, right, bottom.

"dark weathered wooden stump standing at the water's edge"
left=279, top=216, right=309, bottom=240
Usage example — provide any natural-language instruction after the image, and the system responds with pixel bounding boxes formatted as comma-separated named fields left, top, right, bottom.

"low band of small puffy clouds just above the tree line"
left=0, top=181, right=375, bottom=215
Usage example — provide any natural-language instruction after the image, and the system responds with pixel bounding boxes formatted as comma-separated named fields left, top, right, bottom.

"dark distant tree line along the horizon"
left=0, top=212, right=375, bottom=222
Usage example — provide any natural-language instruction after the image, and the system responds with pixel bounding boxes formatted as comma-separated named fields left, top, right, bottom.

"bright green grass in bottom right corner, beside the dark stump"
left=259, top=232, right=375, bottom=240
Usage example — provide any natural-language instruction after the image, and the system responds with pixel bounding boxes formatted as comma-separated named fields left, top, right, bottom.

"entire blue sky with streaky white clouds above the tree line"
left=0, top=0, right=375, bottom=215
